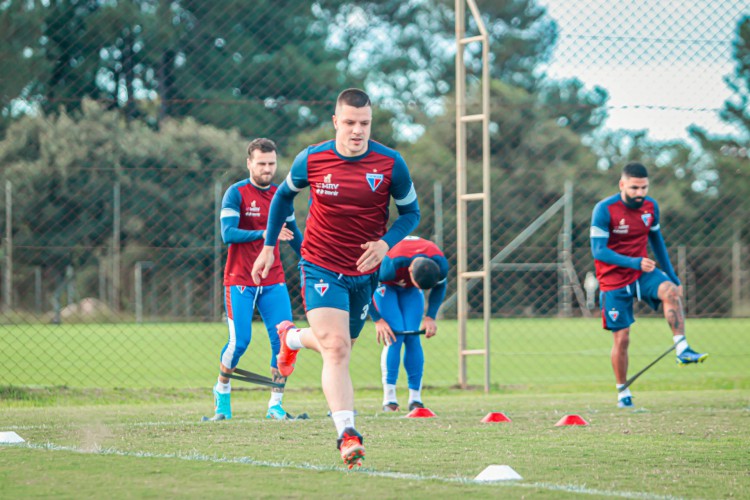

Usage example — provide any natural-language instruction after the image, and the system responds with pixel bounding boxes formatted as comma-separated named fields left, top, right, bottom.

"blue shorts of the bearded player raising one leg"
left=599, top=269, right=669, bottom=332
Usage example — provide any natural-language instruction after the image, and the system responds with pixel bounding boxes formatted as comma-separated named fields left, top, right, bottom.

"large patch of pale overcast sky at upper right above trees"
left=539, top=0, right=750, bottom=139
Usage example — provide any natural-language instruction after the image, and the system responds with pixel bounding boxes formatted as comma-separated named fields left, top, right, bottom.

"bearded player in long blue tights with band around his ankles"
left=210, top=138, right=302, bottom=420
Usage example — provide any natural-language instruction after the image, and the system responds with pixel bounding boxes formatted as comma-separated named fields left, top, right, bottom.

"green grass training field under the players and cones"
left=0, top=319, right=750, bottom=498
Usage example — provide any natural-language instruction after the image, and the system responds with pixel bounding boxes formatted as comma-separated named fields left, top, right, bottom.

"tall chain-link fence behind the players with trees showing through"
left=0, top=0, right=750, bottom=389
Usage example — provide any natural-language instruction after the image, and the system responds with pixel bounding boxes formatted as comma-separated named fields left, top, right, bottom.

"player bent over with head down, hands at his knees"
left=370, top=236, right=448, bottom=411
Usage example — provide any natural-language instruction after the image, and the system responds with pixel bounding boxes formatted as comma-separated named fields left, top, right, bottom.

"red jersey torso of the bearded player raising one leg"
left=594, top=196, right=657, bottom=292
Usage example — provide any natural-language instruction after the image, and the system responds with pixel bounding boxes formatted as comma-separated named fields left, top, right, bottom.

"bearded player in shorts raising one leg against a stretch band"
left=591, top=163, right=708, bottom=408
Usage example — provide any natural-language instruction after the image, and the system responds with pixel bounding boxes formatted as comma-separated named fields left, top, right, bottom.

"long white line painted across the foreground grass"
left=9, top=443, right=679, bottom=500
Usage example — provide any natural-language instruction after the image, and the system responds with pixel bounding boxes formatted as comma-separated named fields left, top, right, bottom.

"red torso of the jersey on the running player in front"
left=302, top=143, right=394, bottom=276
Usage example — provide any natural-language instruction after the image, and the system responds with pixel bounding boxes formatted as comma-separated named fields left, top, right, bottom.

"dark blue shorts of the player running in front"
left=299, top=259, right=378, bottom=339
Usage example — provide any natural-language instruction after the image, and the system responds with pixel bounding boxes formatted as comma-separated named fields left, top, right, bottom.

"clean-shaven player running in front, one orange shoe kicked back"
left=253, top=89, right=420, bottom=468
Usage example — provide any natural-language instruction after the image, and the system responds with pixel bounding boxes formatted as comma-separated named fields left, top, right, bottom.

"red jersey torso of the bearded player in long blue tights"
left=224, top=182, right=285, bottom=286
